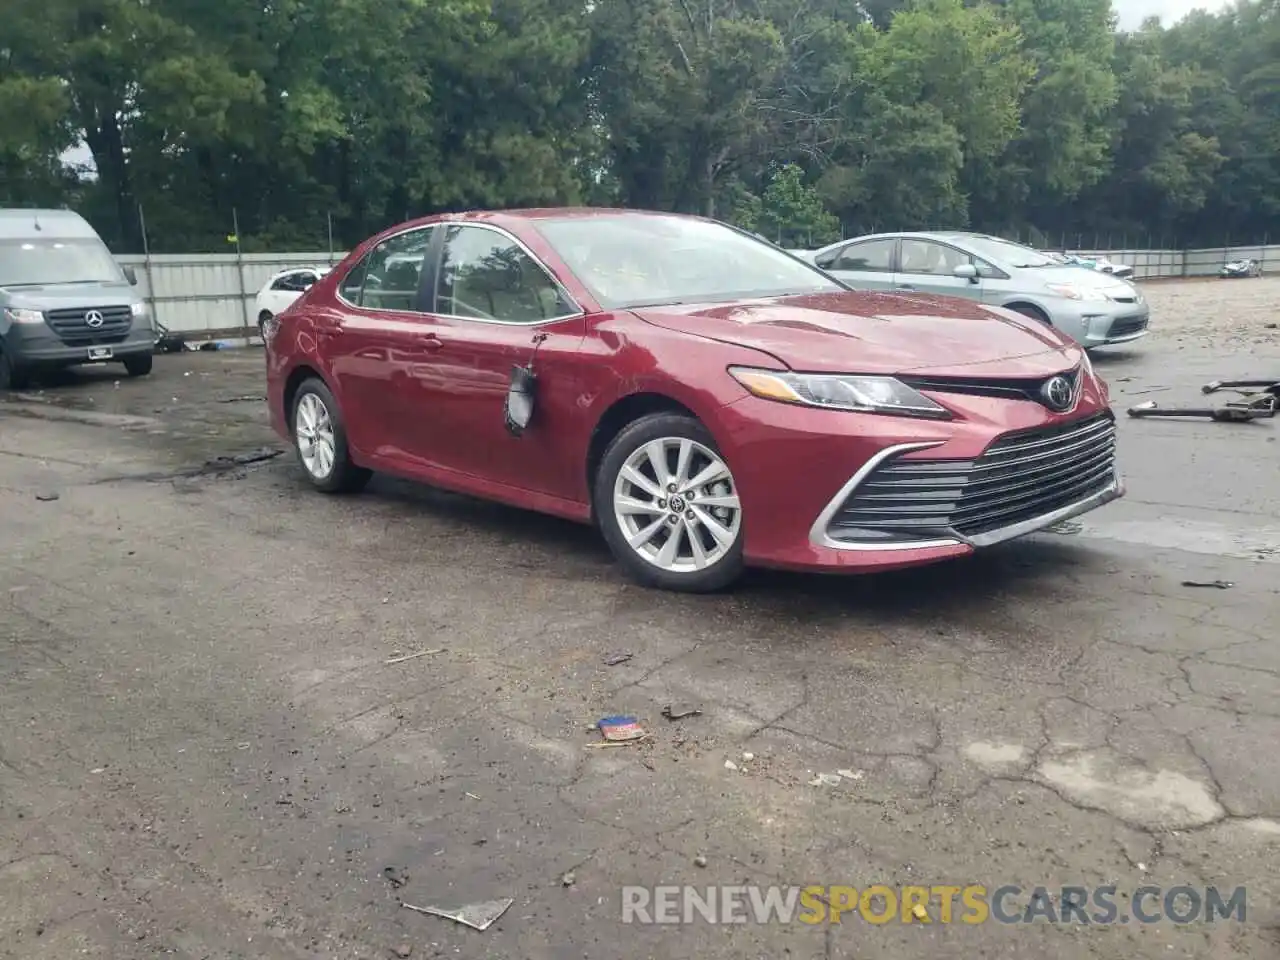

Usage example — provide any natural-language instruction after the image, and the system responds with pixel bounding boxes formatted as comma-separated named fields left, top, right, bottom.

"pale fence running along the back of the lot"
left=118, top=244, right=1280, bottom=339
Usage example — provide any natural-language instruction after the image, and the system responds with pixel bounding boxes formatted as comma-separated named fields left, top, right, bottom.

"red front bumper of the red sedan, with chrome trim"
left=717, top=379, right=1124, bottom=572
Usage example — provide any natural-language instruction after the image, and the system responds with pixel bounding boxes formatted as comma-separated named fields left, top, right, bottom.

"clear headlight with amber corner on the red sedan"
left=728, top=366, right=951, bottom=420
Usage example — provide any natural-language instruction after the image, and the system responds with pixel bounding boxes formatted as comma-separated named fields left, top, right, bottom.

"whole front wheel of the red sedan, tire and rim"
left=593, top=413, right=744, bottom=593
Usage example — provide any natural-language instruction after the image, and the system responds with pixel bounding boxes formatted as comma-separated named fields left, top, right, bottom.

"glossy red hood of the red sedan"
left=635, top=292, right=1080, bottom=376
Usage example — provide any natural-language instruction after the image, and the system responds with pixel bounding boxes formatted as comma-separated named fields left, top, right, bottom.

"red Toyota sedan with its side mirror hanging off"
left=265, top=209, right=1123, bottom=590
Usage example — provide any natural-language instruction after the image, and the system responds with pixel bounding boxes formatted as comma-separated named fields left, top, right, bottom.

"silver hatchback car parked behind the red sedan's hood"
left=801, top=232, right=1151, bottom=347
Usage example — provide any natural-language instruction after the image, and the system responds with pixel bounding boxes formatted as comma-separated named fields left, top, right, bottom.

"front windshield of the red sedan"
left=538, top=214, right=846, bottom=310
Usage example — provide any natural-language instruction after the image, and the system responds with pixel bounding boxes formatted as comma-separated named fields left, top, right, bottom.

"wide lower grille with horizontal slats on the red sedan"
left=827, top=413, right=1116, bottom=544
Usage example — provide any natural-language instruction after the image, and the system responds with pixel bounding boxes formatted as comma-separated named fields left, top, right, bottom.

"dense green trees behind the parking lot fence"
left=0, top=0, right=1280, bottom=251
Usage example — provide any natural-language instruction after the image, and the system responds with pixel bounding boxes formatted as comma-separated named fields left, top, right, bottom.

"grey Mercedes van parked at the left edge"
left=0, top=210, right=155, bottom=390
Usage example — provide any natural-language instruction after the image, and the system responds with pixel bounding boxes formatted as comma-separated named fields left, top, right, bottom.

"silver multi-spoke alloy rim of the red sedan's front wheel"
left=613, top=436, right=742, bottom=573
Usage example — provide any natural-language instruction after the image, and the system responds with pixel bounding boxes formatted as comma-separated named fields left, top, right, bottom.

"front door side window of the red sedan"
left=436, top=225, right=577, bottom=324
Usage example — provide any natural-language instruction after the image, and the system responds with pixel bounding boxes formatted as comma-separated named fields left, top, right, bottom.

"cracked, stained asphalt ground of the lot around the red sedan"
left=0, top=279, right=1280, bottom=960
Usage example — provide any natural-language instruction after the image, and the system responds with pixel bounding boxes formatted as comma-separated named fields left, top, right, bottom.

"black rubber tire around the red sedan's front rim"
left=591, top=413, right=745, bottom=593
